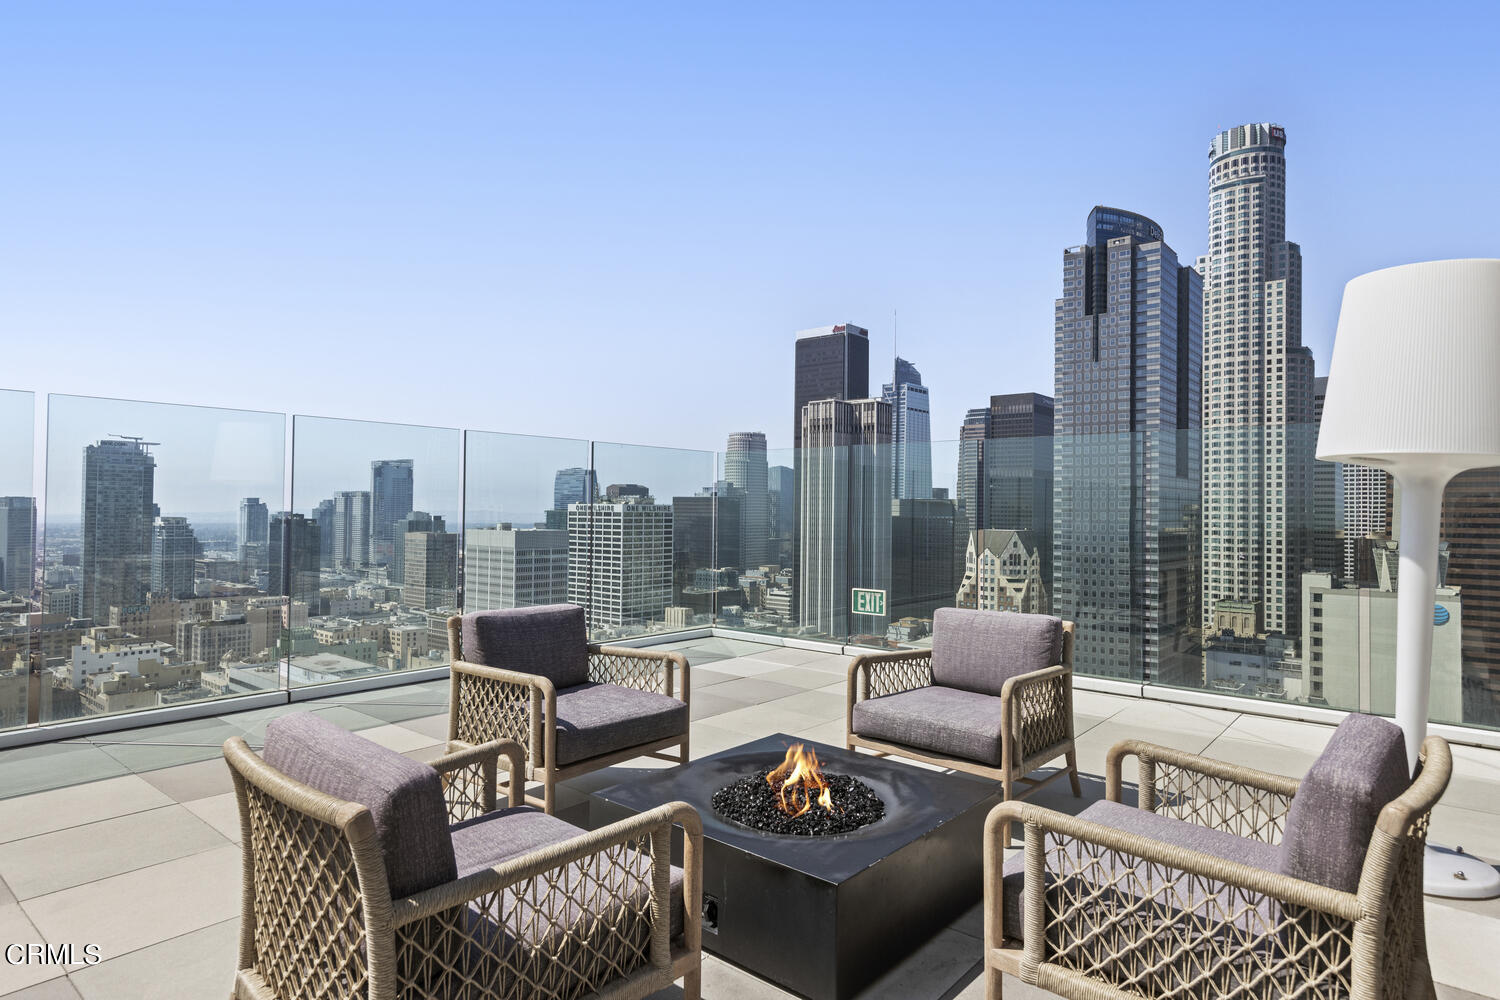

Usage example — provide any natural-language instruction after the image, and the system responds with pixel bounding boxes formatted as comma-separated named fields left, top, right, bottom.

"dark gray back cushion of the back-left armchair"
left=459, top=604, right=588, bottom=688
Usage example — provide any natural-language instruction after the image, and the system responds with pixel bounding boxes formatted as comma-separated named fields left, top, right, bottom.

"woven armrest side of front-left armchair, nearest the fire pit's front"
left=392, top=802, right=704, bottom=997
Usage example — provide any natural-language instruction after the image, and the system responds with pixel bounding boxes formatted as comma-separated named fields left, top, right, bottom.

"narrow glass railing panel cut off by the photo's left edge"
left=0, top=390, right=41, bottom=729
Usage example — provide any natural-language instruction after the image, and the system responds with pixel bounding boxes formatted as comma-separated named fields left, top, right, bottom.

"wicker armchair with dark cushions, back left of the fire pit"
left=449, top=604, right=690, bottom=813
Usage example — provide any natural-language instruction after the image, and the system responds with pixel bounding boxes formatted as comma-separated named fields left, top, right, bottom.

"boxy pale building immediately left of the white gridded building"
left=464, top=523, right=567, bottom=612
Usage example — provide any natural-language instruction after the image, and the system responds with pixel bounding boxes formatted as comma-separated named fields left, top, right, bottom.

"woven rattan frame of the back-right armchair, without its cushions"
left=845, top=622, right=1083, bottom=843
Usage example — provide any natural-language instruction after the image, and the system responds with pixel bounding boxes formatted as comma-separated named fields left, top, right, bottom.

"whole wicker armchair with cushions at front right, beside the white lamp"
left=984, top=715, right=1452, bottom=1000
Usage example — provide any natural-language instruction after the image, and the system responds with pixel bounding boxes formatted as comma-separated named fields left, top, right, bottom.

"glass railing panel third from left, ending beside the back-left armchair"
left=284, top=415, right=462, bottom=687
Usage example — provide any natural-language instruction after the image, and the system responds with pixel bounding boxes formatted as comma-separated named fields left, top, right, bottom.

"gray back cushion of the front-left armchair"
left=264, top=712, right=458, bottom=900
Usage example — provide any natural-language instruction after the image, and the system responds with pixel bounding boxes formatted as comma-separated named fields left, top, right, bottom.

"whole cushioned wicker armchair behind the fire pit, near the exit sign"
left=845, top=607, right=1082, bottom=837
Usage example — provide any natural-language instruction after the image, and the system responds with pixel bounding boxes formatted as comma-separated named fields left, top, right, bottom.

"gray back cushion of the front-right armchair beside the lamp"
left=1281, top=715, right=1412, bottom=892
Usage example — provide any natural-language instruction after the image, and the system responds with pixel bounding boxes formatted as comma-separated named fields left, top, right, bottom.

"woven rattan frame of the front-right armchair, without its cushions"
left=984, top=736, right=1452, bottom=1000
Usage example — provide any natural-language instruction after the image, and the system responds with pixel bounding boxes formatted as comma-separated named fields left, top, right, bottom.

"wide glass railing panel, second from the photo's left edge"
left=35, top=394, right=287, bottom=723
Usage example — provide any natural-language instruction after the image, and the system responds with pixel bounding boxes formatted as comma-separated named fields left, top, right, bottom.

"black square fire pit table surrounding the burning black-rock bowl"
left=590, top=733, right=1002, bottom=1000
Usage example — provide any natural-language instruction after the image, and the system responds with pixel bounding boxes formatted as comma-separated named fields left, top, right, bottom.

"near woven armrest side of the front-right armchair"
left=984, top=801, right=1362, bottom=997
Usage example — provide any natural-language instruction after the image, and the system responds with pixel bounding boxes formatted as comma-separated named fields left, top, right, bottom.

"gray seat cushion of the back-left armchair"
left=557, top=684, right=687, bottom=766
